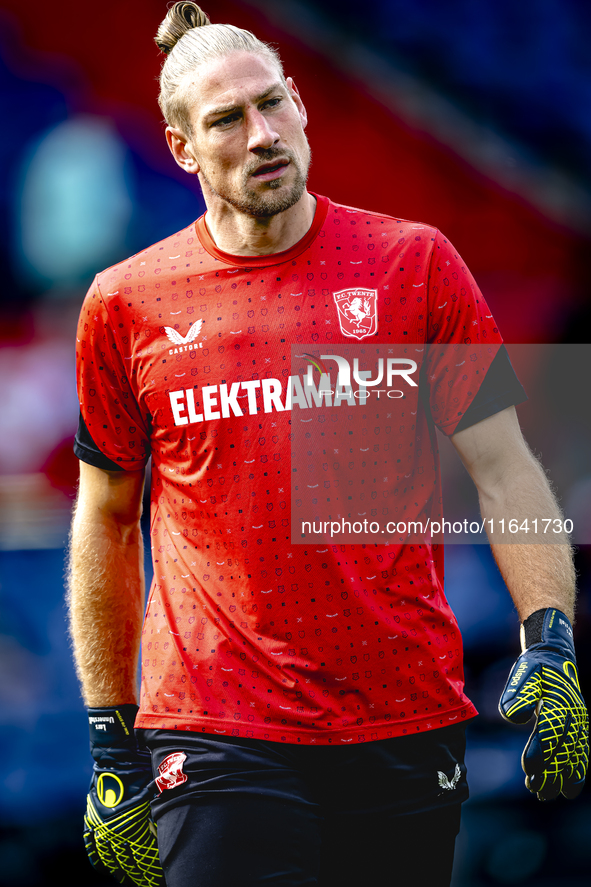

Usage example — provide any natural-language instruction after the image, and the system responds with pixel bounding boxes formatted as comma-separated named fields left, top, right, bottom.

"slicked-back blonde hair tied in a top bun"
left=155, top=2, right=285, bottom=136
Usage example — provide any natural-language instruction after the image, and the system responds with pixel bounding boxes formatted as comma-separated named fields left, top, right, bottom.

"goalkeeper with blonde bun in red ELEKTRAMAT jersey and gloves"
left=70, top=3, right=587, bottom=887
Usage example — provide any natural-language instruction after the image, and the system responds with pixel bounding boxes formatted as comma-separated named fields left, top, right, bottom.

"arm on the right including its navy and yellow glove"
left=452, top=407, right=589, bottom=800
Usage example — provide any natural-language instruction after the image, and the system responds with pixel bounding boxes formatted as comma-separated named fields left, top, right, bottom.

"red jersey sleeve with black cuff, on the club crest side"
left=423, top=231, right=525, bottom=436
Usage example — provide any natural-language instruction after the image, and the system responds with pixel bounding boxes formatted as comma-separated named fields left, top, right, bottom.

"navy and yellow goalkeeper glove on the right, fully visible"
left=499, top=607, right=589, bottom=801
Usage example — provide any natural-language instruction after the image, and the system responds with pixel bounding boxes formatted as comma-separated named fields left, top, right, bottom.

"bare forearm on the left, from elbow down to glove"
left=69, top=504, right=144, bottom=707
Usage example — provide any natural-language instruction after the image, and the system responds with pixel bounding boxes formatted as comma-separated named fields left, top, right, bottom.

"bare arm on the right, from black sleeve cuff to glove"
left=451, top=407, right=575, bottom=622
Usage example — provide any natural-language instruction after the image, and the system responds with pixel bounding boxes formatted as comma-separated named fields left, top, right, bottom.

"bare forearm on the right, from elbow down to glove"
left=480, top=453, right=575, bottom=622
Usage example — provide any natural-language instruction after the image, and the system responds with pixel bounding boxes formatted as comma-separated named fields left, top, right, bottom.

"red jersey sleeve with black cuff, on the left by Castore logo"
left=74, top=280, right=150, bottom=471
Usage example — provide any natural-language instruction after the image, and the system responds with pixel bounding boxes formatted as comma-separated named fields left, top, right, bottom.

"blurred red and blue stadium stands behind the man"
left=0, top=0, right=591, bottom=887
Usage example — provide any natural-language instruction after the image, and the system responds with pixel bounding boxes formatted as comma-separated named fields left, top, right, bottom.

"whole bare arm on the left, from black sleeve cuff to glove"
left=69, top=462, right=144, bottom=708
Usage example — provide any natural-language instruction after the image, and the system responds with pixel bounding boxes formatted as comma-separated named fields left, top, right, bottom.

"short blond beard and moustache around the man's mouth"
left=201, top=142, right=310, bottom=219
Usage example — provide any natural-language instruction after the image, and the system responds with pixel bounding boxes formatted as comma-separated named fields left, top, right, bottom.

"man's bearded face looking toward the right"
left=179, top=52, right=310, bottom=218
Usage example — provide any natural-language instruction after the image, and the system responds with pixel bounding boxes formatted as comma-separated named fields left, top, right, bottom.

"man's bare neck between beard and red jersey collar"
left=204, top=191, right=316, bottom=256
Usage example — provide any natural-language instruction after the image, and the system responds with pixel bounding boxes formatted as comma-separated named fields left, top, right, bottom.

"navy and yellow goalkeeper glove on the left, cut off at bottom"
left=84, top=705, right=165, bottom=887
